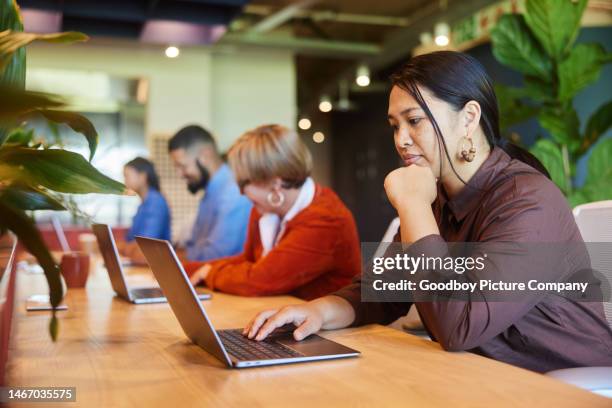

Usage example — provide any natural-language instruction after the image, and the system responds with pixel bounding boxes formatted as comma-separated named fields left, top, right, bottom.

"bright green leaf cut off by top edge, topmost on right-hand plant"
left=525, top=0, right=587, bottom=61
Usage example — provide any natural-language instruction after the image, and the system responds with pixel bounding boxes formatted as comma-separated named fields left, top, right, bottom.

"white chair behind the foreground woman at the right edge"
left=546, top=200, right=612, bottom=398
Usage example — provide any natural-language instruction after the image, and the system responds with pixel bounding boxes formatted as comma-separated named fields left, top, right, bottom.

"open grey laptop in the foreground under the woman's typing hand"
left=136, top=237, right=359, bottom=368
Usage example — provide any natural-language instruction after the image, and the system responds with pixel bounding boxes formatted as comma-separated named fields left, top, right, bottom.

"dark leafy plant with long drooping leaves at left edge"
left=0, top=0, right=124, bottom=341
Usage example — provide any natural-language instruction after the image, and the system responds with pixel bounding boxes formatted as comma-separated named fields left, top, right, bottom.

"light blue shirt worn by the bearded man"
left=187, top=164, right=251, bottom=261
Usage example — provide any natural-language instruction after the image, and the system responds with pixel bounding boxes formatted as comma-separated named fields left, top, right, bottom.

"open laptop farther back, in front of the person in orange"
left=92, top=224, right=211, bottom=304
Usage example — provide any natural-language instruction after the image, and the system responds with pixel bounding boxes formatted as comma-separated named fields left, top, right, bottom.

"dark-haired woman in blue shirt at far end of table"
left=120, top=157, right=170, bottom=263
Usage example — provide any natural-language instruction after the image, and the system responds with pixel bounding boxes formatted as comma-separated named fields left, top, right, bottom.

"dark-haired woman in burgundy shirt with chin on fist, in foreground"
left=244, top=51, right=612, bottom=372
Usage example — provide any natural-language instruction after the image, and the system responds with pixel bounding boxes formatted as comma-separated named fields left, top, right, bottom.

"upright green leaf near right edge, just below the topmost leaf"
left=558, top=44, right=606, bottom=101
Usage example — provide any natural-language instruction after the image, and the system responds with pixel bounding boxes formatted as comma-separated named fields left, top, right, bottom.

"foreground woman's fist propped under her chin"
left=385, top=165, right=438, bottom=211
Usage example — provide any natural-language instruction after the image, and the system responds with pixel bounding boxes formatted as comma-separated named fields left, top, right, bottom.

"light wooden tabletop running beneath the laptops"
left=7, top=260, right=612, bottom=408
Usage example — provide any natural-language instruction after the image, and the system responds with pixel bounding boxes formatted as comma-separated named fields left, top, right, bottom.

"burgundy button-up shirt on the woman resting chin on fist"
left=335, top=148, right=612, bottom=372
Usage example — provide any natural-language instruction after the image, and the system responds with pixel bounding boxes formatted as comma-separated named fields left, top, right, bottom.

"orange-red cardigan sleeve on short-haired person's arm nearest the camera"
left=206, top=219, right=341, bottom=296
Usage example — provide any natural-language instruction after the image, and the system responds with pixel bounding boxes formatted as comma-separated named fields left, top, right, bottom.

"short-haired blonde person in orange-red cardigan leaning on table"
left=185, top=125, right=361, bottom=299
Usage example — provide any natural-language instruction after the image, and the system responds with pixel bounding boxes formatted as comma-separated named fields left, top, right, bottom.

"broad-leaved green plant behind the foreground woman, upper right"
left=491, top=0, right=612, bottom=206
